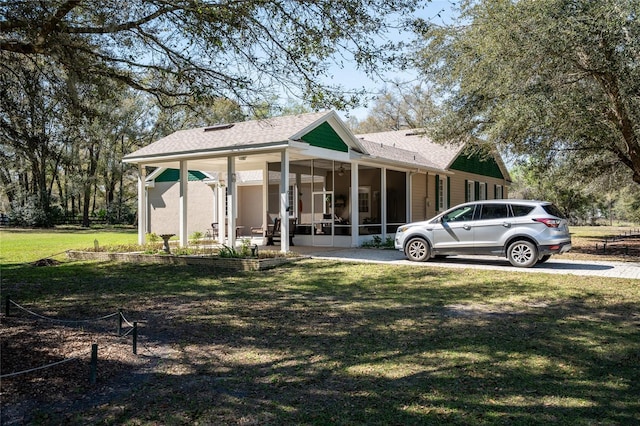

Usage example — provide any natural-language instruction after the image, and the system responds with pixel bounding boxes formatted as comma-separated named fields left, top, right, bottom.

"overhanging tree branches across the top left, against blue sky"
left=0, top=0, right=417, bottom=108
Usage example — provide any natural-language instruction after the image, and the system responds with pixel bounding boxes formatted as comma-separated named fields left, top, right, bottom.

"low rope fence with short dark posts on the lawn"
left=0, top=296, right=138, bottom=384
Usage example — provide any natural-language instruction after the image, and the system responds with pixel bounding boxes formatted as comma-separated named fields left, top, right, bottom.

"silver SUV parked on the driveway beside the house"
left=395, top=200, right=571, bottom=268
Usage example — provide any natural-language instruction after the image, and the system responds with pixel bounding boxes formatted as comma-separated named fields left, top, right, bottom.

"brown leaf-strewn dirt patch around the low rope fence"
left=0, top=316, right=155, bottom=425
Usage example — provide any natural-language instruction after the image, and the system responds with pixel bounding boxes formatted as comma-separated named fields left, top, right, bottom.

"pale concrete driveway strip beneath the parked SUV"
left=292, top=246, right=640, bottom=279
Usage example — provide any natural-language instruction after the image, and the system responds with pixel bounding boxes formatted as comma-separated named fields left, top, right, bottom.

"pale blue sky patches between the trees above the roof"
left=327, top=0, right=457, bottom=120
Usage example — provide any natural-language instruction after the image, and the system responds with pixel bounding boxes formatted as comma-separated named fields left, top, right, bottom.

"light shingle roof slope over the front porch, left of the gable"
left=125, top=111, right=335, bottom=160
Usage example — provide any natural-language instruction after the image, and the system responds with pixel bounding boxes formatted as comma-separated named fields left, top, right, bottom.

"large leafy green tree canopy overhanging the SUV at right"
left=417, top=0, right=640, bottom=184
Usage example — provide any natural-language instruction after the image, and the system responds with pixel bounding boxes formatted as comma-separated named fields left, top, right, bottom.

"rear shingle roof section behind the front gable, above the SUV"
left=356, top=130, right=464, bottom=170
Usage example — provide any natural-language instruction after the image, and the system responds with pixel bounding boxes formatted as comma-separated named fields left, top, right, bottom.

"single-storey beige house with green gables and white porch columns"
left=124, top=111, right=510, bottom=251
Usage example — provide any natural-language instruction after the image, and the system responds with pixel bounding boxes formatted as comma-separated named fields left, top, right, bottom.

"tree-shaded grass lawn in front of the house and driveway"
left=0, top=228, right=640, bottom=425
